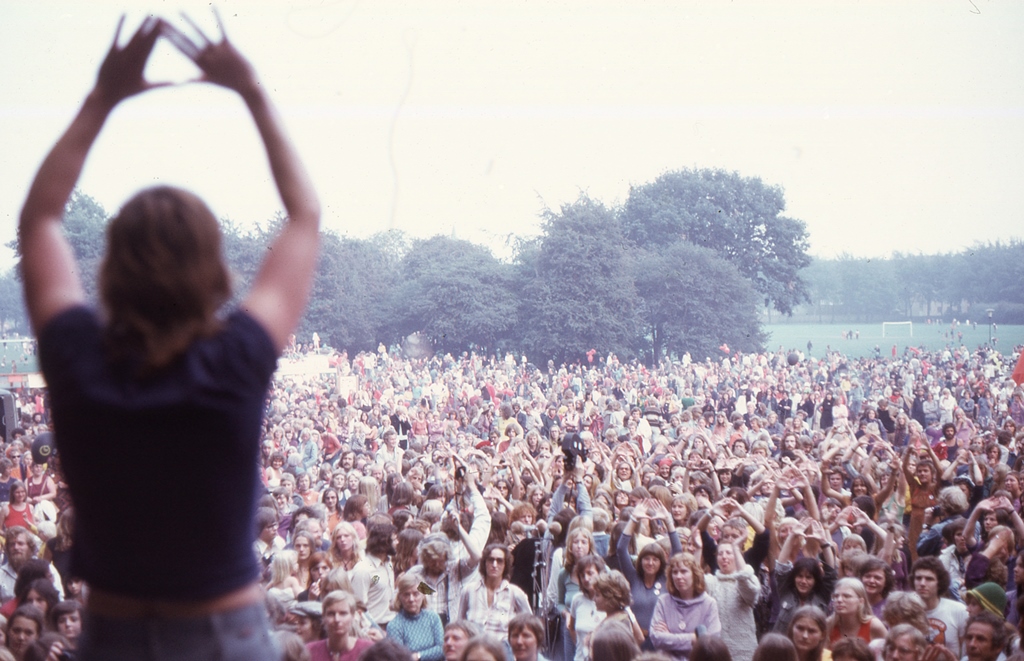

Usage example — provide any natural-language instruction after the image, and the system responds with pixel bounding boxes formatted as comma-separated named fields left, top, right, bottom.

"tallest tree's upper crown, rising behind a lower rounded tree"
left=621, top=170, right=810, bottom=314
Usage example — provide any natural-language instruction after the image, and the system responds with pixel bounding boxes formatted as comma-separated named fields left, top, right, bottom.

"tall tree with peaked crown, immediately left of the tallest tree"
left=519, top=195, right=637, bottom=362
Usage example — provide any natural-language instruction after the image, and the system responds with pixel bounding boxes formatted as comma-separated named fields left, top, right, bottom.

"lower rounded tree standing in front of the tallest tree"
left=636, top=241, right=765, bottom=363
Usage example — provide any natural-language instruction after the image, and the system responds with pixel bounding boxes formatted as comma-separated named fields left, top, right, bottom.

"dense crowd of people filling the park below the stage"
left=0, top=343, right=1024, bottom=661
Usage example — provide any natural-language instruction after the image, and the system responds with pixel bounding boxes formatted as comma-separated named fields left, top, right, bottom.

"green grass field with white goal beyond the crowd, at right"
left=765, top=322, right=1024, bottom=357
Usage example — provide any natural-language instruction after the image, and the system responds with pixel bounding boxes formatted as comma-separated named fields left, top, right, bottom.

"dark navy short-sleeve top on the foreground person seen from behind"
left=39, top=307, right=276, bottom=601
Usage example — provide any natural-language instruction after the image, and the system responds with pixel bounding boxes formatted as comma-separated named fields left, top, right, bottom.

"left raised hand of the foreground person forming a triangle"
left=96, top=15, right=167, bottom=107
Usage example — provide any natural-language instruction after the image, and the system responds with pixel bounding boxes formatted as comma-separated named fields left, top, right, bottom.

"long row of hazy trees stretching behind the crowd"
left=0, top=170, right=1024, bottom=363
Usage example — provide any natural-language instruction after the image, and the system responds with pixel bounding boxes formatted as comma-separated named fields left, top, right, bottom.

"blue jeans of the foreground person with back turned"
left=75, top=604, right=282, bottom=661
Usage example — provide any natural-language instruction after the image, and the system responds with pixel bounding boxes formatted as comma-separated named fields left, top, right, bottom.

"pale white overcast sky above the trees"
left=0, top=0, right=1024, bottom=266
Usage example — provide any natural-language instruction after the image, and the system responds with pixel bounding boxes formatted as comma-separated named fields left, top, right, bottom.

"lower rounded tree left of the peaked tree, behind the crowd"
left=390, top=236, right=518, bottom=352
